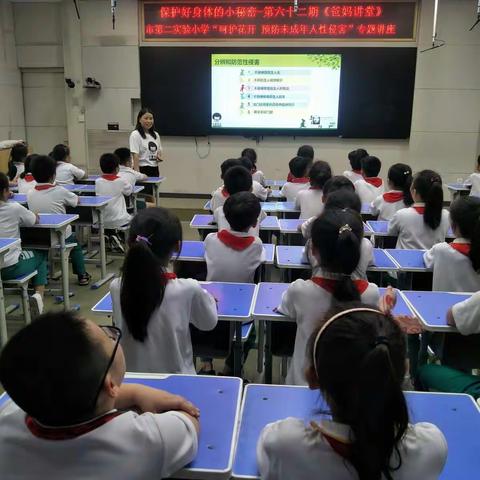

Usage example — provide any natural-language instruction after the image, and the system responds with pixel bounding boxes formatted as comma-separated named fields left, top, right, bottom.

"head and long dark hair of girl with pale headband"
left=306, top=303, right=409, bottom=480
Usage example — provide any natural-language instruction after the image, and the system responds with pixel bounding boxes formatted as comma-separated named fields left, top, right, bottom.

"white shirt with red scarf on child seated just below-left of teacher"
left=95, top=174, right=133, bottom=229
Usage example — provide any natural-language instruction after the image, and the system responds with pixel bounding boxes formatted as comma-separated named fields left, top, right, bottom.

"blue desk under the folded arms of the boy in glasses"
left=0, top=373, right=242, bottom=480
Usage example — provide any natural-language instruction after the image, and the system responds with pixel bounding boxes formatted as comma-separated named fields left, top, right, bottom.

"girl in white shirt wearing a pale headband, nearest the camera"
left=257, top=303, right=448, bottom=480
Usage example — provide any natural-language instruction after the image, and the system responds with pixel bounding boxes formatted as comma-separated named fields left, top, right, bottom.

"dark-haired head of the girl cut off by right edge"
left=450, top=196, right=480, bottom=272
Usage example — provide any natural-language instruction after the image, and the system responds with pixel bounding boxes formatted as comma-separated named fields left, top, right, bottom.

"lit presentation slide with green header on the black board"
left=211, top=54, right=342, bottom=130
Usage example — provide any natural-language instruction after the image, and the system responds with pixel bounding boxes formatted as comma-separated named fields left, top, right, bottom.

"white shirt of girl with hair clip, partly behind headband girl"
left=279, top=271, right=380, bottom=384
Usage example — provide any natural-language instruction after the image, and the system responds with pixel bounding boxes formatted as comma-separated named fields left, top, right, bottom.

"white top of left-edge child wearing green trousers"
left=0, top=202, right=37, bottom=268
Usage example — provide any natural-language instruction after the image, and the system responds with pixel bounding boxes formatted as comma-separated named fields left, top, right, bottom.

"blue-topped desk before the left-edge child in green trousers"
left=20, top=213, right=78, bottom=310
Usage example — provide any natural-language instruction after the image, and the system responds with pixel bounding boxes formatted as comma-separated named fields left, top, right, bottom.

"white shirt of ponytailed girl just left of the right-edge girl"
left=388, top=203, right=450, bottom=250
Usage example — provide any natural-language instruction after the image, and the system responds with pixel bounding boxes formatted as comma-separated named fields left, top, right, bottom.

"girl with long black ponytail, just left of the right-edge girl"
left=388, top=170, right=450, bottom=250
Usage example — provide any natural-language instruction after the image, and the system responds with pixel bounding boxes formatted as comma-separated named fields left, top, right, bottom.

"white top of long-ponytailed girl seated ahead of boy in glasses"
left=110, top=278, right=217, bottom=375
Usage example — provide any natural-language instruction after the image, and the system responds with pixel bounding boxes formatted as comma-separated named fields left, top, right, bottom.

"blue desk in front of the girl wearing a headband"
left=233, top=384, right=480, bottom=480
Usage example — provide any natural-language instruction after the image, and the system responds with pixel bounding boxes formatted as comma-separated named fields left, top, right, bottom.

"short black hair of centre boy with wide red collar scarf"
left=223, top=192, right=261, bottom=232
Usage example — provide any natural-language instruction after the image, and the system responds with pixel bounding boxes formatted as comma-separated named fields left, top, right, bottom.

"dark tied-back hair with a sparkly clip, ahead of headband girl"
left=312, top=208, right=363, bottom=302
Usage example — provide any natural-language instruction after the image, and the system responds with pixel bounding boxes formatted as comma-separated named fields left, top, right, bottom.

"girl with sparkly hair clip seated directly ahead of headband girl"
left=278, top=209, right=379, bottom=385
